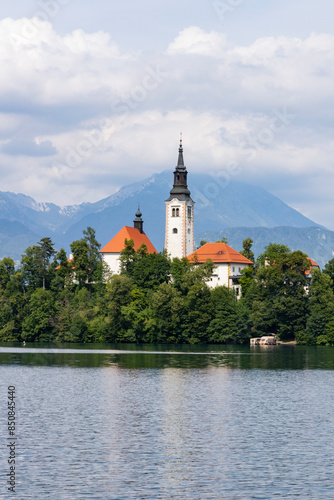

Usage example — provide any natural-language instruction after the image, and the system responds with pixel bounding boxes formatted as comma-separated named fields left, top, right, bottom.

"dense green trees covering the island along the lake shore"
left=0, top=227, right=334, bottom=345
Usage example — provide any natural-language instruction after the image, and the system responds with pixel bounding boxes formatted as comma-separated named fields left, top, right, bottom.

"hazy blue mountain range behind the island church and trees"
left=0, top=171, right=334, bottom=266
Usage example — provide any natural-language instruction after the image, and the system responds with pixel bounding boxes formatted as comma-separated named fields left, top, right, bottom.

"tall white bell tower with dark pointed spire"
left=165, top=138, right=195, bottom=259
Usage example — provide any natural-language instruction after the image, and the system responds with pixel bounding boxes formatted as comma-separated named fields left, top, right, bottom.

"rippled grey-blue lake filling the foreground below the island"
left=0, top=343, right=334, bottom=500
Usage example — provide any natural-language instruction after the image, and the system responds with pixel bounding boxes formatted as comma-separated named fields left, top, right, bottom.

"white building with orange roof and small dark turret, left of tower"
left=100, top=207, right=157, bottom=274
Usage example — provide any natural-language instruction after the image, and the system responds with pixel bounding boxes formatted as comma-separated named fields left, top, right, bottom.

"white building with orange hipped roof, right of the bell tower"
left=188, top=243, right=253, bottom=297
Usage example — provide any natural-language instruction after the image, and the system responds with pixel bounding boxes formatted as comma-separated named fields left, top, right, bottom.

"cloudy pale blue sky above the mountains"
left=0, top=0, right=334, bottom=230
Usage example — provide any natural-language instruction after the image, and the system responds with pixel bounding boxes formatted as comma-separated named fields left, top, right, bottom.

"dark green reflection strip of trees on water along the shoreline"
left=0, top=343, right=334, bottom=370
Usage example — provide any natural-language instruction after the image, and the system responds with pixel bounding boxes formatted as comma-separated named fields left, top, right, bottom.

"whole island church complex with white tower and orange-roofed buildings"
left=100, top=139, right=253, bottom=296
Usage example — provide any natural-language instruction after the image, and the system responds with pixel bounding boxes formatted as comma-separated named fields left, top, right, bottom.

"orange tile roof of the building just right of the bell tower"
left=188, top=243, right=253, bottom=264
